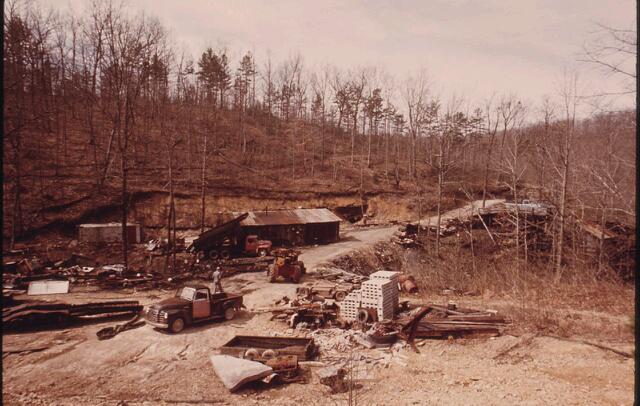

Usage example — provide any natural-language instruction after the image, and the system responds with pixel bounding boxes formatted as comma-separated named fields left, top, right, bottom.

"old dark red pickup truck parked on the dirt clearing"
left=145, top=285, right=244, bottom=333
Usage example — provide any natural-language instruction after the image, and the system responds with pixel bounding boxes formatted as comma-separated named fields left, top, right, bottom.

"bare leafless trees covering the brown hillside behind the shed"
left=3, top=1, right=636, bottom=272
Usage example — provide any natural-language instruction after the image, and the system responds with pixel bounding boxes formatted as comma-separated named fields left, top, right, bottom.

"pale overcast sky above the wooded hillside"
left=41, top=0, right=636, bottom=114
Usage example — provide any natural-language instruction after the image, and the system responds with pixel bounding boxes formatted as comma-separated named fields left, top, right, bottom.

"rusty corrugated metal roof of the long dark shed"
left=234, top=208, right=340, bottom=226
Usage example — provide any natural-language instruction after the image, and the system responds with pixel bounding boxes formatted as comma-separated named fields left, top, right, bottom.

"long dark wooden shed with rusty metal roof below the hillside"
left=234, top=208, right=340, bottom=246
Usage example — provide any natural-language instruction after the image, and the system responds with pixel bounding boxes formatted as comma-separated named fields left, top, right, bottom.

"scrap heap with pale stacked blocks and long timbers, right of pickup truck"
left=265, top=271, right=509, bottom=356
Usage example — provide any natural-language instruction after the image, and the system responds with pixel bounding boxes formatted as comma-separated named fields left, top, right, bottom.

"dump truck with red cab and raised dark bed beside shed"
left=187, top=213, right=272, bottom=259
